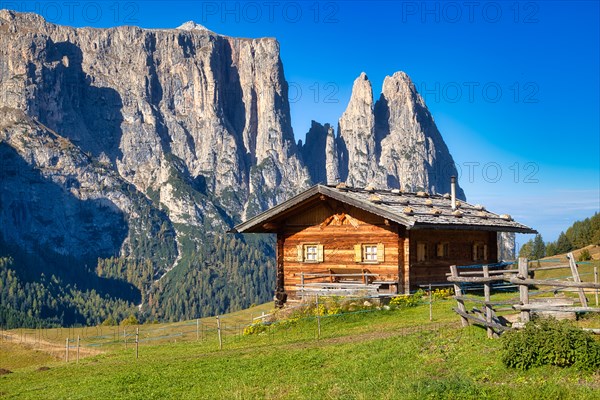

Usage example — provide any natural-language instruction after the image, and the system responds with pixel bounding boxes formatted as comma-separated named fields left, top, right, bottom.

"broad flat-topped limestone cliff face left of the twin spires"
left=0, top=11, right=309, bottom=225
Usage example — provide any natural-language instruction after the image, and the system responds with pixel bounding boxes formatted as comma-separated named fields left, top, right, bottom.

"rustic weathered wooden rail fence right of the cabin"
left=448, top=253, right=600, bottom=338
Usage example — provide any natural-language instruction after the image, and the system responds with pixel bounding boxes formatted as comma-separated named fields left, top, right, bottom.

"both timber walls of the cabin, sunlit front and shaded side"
left=276, top=197, right=498, bottom=298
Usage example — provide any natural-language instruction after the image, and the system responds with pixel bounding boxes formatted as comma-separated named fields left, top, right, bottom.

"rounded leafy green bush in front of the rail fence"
left=502, top=319, right=600, bottom=371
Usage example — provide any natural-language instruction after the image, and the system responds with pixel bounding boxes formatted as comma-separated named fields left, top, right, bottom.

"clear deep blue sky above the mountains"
left=0, top=0, right=600, bottom=242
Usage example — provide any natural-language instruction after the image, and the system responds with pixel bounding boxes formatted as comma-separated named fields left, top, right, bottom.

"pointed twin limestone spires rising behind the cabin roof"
left=303, top=72, right=465, bottom=199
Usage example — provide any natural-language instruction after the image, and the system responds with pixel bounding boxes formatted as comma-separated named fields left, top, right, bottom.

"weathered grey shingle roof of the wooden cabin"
left=232, top=185, right=537, bottom=233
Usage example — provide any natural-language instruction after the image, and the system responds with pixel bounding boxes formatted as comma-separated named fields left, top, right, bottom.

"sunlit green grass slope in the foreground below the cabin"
left=0, top=300, right=600, bottom=399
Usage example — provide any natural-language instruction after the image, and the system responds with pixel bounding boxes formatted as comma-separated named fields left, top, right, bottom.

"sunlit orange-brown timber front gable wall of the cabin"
left=282, top=199, right=404, bottom=298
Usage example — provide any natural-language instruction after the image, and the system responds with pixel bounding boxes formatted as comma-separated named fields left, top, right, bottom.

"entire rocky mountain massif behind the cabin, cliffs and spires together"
left=0, top=10, right=474, bottom=322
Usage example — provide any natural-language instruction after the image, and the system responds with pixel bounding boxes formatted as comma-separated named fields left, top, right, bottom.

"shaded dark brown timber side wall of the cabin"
left=408, top=229, right=498, bottom=290
